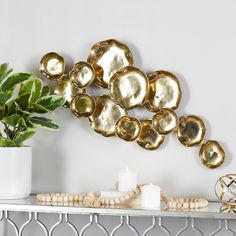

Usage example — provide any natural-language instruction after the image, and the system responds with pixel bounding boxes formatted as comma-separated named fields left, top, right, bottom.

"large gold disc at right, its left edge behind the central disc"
left=146, top=71, right=182, bottom=112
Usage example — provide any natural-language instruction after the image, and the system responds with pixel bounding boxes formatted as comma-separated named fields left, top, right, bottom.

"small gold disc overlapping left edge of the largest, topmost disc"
left=69, top=61, right=95, bottom=88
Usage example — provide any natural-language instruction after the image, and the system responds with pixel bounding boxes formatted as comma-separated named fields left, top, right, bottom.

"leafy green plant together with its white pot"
left=0, top=63, right=65, bottom=199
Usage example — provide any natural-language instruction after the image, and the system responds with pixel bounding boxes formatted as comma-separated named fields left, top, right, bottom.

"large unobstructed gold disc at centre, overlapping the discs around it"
left=109, top=66, right=149, bottom=109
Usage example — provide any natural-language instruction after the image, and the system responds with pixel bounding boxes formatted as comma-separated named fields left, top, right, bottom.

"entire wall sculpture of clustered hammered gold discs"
left=40, top=39, right=225, bottom=169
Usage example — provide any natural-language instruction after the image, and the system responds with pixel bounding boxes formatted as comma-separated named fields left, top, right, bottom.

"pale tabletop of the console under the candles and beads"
left=0, top=196, right=236, bottom=219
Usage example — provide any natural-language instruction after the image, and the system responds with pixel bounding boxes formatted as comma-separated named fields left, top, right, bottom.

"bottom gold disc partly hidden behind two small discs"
left=137, top=120, right=164, bottom=150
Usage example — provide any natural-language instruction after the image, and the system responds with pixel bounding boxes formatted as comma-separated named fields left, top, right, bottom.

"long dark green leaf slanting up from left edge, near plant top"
left=1, top=73, right=31, bottom=92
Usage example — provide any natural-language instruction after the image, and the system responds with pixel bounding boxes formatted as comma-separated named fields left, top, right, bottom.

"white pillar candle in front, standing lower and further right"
left=141, top=184, right=161, bottom=208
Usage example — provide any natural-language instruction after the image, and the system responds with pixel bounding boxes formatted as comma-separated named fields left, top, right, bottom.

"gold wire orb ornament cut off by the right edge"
left=215, top=174, right=236, bottom=206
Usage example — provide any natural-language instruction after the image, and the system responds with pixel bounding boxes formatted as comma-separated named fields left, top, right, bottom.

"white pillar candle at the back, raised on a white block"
left=118, top=168, right=137, bottom=192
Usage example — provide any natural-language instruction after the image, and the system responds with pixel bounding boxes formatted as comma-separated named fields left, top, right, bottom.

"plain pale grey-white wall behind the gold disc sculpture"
left=0, top=0, right=236, bottom=234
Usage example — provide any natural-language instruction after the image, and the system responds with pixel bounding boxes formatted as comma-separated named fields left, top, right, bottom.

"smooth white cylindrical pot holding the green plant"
left=0, top=147, right=32, bottom=199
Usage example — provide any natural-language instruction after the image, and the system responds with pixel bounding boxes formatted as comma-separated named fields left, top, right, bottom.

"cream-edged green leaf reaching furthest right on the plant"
left=37, top=95, right=65, bottom=111
